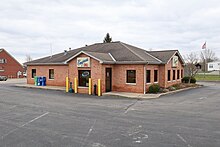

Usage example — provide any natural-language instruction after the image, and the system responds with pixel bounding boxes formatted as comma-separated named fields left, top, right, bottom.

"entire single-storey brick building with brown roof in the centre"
left=26, top=42, right=184, bottom=93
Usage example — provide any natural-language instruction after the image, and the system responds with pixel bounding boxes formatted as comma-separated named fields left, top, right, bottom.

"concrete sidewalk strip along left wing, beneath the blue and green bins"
left=14, top=84, right=66, bottom=91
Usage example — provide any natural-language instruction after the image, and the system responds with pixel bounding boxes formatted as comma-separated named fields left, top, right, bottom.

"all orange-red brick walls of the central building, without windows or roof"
left=27, top=54, right=183, bottom=93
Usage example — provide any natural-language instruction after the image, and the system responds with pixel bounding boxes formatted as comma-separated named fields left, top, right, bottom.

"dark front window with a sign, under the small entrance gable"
left=78, top=70, right=91, bottom=87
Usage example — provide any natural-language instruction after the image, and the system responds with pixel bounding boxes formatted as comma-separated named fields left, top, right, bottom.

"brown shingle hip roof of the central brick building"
left=25, top=42, right=182, bottom=65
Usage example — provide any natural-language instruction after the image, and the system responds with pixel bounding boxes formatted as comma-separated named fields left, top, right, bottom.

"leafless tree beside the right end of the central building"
left=184, top=53, right=199, bottom=83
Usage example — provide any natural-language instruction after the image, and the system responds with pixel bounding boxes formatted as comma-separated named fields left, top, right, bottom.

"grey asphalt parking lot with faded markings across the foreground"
left=0, top=80, right=220, bottom=147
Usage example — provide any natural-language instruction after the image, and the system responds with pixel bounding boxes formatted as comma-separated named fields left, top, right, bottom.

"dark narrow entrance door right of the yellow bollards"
left=105, top=68, right=112, bottom=92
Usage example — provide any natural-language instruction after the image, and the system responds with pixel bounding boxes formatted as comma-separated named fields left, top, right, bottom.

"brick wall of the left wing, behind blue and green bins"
left=27, top=65, right=68, bottom=86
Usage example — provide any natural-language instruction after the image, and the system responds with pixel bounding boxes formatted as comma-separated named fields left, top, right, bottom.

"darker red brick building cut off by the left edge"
left=0, top=49, right=24, bottom=78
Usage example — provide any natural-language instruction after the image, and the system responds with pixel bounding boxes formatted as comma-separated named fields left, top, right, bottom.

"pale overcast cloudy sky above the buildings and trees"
left=0, top=0, right=220, bottom=63
